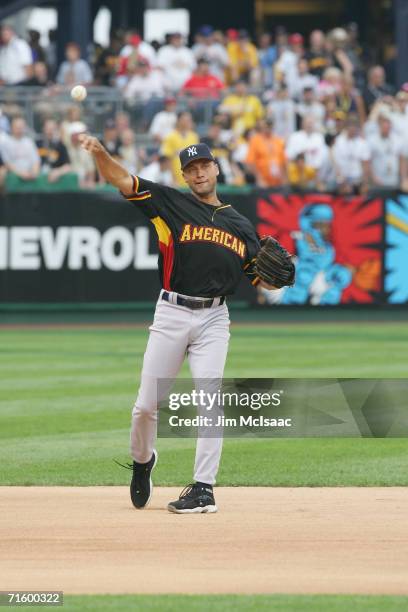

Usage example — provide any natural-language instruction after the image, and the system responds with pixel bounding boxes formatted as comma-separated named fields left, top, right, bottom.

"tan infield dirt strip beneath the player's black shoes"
left=0, top=487, right=408, bottom=594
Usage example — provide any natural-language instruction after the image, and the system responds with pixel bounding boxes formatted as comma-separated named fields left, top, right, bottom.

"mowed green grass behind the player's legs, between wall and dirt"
left=0, top=323, right=408, bottom=486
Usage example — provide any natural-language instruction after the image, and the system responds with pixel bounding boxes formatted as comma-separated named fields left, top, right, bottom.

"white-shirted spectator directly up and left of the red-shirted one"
left=157, top=33, right=196, bottom=91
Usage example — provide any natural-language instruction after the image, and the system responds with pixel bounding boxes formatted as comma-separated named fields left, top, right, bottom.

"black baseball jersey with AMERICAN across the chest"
left=122, top=177, right=260, bottom=298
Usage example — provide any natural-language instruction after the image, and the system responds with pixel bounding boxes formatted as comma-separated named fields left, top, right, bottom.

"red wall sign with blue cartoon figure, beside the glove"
left=257, top=193, right=383, bottom=304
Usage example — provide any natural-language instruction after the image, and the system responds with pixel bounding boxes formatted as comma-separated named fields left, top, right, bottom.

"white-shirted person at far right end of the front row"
left=367, top=112, right=403, bottom=189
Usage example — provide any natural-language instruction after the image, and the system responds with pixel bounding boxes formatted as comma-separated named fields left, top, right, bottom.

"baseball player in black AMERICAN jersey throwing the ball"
left=81, top=134, right=292, bottom=514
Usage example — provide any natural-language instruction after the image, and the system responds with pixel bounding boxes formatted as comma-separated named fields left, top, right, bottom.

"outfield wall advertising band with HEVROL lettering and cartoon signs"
left=0, top=190, right=408, bottom=307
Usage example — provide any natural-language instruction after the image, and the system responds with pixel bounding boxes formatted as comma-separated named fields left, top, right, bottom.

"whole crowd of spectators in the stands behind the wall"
left=0, top=24, right=408, bottom=194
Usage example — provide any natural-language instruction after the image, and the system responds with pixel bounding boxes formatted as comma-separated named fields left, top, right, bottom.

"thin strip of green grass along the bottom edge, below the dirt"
left=58, top=595, right=408, bottom=612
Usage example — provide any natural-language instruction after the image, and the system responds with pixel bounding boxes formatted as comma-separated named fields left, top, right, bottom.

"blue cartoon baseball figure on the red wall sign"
left=279, top=204, right=353, bottom=305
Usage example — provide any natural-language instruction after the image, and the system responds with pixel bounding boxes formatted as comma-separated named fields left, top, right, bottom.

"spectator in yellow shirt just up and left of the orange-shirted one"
left=220, top=81, right=265, bottom=135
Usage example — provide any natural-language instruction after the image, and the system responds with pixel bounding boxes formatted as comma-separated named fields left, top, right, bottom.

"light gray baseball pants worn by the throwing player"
left=130, top=290, right=230, bottom=484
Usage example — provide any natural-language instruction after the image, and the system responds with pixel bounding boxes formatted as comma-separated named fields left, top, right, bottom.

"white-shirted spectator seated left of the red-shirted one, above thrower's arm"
left=123, top=59, right=165, bottom=102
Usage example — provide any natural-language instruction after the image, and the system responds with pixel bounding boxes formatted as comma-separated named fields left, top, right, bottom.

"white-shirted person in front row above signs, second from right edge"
left=332, top=115, right=370, bottom=194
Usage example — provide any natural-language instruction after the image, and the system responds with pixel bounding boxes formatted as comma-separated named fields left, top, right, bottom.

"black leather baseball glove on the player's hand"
left=255, top=236, right=295, bottom=289
